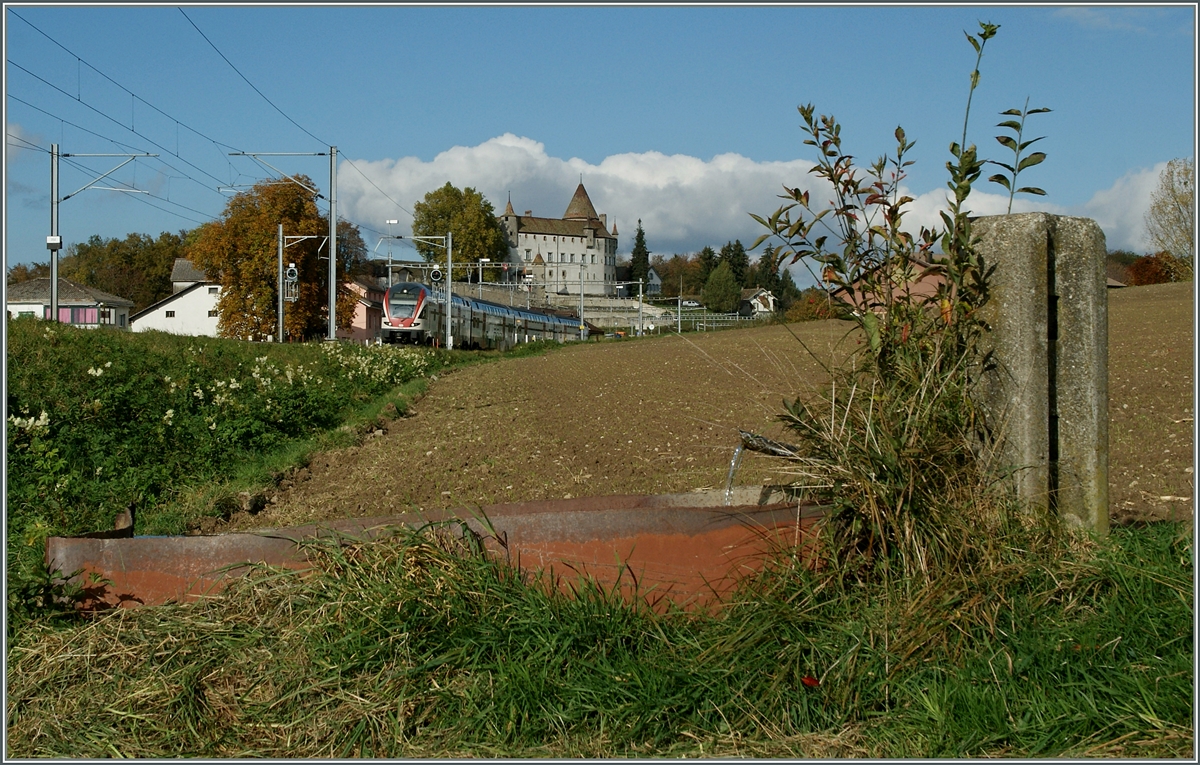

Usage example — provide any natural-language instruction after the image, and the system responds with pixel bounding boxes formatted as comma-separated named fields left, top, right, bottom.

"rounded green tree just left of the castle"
left=413, top=181, right=509, bottom=276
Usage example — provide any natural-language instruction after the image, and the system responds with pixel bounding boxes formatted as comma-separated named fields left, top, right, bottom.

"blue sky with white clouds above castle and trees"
left=5, top=5, right=1196, bottom=282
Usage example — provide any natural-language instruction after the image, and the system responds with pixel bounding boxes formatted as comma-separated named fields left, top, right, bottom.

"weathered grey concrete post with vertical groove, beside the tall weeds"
left=973, top=212, right=1109, bottom=534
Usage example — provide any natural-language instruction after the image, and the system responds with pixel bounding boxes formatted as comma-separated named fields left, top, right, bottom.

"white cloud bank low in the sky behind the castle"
left=338, top=133, right=1158, bottom=262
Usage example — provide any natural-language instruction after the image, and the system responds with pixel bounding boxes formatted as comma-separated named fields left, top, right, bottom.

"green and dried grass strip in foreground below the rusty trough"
left=6, top=517, right=1194, bottom=758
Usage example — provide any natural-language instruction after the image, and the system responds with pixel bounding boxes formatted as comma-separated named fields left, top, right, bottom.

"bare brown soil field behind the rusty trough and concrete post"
left=221, top=283, right=1194, bottom=530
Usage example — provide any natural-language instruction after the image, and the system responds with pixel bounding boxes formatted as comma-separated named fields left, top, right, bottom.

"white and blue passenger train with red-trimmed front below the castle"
left=380, top=282, right=592, bottom=349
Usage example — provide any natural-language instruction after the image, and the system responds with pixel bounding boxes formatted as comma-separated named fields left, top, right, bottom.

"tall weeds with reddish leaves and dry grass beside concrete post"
left=755, top=23, right=1045, bottom=580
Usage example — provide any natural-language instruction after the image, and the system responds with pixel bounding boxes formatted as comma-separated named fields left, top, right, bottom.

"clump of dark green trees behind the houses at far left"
left=59, top=231, right=187, bottom=312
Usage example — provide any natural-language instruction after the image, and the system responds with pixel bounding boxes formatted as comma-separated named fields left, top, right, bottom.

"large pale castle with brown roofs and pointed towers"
left=500, top=183, right=617, bottom=295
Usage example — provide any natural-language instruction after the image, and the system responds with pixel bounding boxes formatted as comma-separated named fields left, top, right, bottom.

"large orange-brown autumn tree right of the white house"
left=188, top=175, right=366, bottom=341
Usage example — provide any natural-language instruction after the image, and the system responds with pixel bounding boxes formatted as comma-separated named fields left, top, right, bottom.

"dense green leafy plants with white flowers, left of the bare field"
left=6, top=319, right=443, bottom=547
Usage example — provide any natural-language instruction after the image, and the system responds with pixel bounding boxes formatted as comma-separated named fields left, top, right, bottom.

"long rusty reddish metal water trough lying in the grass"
left=46, top=492, right=822, bottom=608
